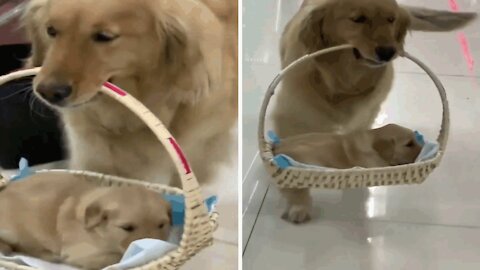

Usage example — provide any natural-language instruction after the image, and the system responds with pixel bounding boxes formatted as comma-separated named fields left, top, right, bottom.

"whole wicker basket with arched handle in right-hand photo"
left=258, top=45, right=450, bottom=189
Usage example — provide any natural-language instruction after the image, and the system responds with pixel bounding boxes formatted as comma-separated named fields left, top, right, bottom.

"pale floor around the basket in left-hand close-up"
left=0, top=129, right=239, bottom=270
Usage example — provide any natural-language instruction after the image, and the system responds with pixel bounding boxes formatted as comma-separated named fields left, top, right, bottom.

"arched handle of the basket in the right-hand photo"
left=258, top=45, right=450, bottom=159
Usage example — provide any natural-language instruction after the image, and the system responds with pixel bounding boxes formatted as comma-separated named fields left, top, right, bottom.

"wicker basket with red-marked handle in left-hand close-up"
left=0, top=68, right=218, bottom=270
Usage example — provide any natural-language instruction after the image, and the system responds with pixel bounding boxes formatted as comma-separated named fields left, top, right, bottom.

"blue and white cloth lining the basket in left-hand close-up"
left=0, top=158, right=218, bottom=270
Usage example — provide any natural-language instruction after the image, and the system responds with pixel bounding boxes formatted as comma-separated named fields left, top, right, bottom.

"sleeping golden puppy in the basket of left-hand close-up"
left=0, top=174, right=171, bottom=270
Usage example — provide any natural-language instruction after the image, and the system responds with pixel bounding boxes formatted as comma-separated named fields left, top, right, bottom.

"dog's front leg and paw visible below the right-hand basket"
left=280, top=188, right=312, bottom=224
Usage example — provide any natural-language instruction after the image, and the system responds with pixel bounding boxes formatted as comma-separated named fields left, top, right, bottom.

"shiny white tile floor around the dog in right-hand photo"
left=246, top=0, right=480, bottom=270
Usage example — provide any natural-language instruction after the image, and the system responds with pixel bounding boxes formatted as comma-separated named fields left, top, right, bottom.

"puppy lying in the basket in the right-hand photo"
left=274, top=124, right=422, bottom=169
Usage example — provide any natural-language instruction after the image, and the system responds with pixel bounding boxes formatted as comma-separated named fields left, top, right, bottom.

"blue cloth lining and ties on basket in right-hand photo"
left=268, top=130, right=439, bottom=170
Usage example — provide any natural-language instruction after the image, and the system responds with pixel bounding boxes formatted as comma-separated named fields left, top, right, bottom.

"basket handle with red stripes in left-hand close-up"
left=0, top=68, right=209, bottom=224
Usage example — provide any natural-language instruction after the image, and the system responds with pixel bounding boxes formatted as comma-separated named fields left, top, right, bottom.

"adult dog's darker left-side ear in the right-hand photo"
left=299, top=4, right=332, bottom=52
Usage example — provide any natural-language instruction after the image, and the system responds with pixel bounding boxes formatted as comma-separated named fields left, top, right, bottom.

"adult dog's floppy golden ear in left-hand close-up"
left=154, top=7, right=222, bottom=103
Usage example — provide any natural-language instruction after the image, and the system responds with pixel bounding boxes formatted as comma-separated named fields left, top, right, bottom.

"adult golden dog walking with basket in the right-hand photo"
left=273, top=0, right=476, bottom=223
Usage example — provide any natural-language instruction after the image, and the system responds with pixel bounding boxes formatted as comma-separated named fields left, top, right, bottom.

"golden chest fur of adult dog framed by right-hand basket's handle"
left=273, top=57, right=393, bottom=136
